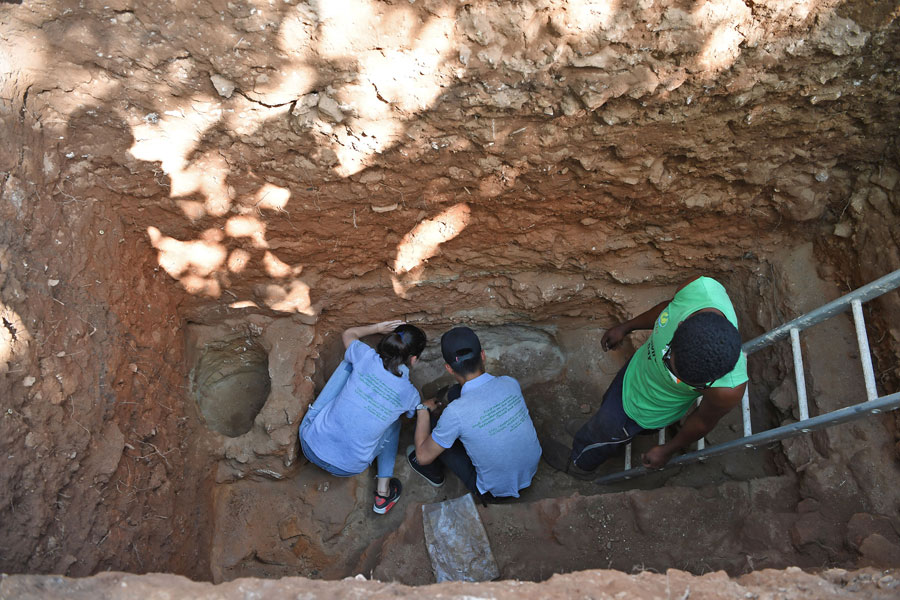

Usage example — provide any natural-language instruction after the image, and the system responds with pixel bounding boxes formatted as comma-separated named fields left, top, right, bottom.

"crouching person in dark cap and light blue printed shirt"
left=407, top=327, right=541, bottom=502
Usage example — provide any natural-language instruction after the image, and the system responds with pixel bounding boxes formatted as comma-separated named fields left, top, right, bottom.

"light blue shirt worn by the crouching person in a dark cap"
left=431, top=373, right=541, bottom=498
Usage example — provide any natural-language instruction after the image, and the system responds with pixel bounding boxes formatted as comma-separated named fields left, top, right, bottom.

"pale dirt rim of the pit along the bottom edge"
left=0, top=569, right=898, bottom=600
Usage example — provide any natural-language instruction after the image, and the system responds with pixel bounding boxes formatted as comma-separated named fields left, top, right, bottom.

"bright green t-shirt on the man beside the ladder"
left=622, top=277, right=747, bottom=429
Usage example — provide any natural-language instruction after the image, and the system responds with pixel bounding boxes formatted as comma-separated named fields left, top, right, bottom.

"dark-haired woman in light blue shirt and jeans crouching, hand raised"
left=300, top=321, right=426, bottom=514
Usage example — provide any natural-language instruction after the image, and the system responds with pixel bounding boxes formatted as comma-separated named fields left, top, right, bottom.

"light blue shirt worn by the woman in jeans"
left=303, top=340, right=420, bottom=473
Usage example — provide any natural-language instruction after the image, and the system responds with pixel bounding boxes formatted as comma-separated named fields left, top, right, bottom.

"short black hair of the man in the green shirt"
left=669, top=312, right=741, bottom=385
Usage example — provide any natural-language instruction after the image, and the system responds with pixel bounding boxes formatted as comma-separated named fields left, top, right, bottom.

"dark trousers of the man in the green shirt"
left=572, top=361, right=657, bottom=471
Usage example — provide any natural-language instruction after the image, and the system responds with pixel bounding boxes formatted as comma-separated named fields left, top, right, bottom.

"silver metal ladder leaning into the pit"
left=594, top=269, right=900, bottom=484
